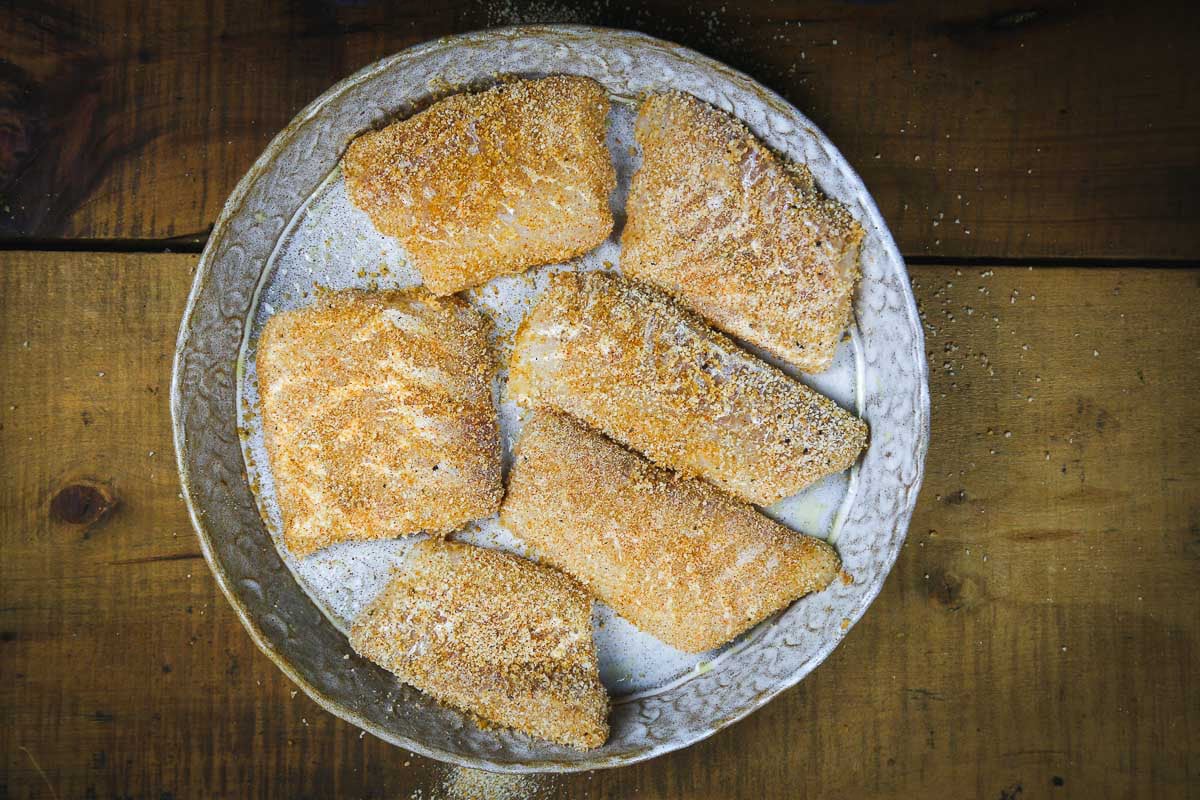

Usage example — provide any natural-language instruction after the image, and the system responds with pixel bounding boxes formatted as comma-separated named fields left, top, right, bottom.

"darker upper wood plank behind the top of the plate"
left=0, top=0, right=1200, bottom=259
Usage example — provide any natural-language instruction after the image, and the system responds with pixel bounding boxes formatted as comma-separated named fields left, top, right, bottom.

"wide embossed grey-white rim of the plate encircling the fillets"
left=172, top=26, right=929, bottom=771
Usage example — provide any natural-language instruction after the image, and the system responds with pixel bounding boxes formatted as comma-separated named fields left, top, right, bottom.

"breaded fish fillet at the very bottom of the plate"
left=350, top=540, right=608, bottom=750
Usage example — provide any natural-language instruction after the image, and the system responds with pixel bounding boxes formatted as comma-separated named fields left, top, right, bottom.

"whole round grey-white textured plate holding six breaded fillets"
left=172, top=26, right=929, bottom=771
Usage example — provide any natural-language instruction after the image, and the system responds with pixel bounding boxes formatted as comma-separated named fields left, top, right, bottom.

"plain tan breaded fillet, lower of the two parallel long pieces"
left=500, top=411, right=841, bottom=652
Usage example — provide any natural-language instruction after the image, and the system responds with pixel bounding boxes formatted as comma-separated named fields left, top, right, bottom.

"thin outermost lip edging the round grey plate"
left=170, top=25, right=930, bottom=772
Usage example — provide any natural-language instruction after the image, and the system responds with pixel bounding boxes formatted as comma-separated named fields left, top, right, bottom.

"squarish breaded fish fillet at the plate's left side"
left=257, top=289, right=503, bottom=555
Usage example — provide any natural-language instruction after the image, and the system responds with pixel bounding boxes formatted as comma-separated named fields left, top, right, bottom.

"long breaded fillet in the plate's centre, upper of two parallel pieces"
left=508, top=272, right=866, bottom=505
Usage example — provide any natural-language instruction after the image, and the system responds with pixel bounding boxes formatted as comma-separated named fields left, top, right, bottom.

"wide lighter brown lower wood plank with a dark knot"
left=0, top=252, right=1200, bottom=800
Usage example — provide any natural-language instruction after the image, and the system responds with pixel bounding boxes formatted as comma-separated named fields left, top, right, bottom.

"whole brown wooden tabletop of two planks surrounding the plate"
left=0, top=0, right=1200, bottom=800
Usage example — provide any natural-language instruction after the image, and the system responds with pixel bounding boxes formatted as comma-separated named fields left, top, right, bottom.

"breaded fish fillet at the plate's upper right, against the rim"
left=620, top=92, right=863, bottom=372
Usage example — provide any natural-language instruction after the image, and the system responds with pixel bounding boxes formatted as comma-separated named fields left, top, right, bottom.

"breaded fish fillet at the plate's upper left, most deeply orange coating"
left=342, top=76, right=617, bottom=295
